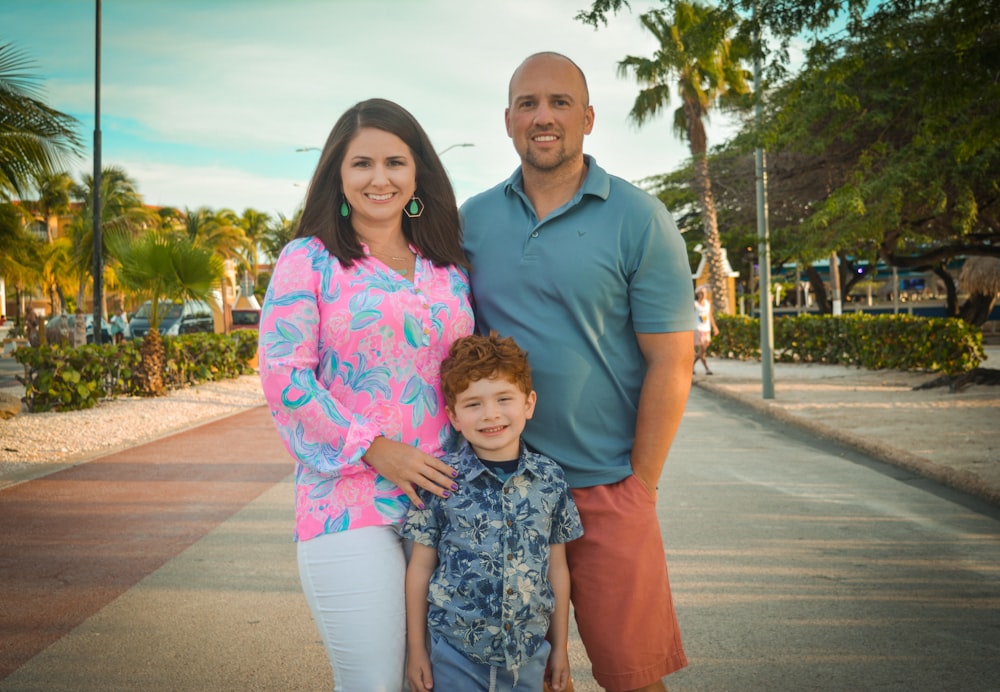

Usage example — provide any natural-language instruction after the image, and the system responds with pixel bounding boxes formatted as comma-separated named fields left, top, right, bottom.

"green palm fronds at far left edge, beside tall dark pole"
left=0, top=43, right=81, bottom=200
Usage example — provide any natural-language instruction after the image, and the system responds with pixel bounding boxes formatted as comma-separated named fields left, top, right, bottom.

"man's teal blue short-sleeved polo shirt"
left=461, top=156, right=694, bottom=488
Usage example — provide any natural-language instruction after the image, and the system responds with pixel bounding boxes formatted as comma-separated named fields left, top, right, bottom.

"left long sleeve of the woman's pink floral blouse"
left=258, top=241, right=381, bottom=477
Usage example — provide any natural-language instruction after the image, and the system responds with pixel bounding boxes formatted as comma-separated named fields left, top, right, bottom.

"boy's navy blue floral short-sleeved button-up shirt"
left=402, top=442, right=583, bottom=670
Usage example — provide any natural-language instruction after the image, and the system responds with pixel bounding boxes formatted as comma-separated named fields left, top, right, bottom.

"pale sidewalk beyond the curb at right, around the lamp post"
left=694, top=345, right=1000, bottom=506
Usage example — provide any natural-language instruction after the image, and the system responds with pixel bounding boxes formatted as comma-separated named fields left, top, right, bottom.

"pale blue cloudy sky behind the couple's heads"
left=0, top=0, right=733, bottom=217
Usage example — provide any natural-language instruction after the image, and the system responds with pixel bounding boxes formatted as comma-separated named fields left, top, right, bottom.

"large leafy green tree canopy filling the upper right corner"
left=752, top=0, right=1000, bottom=315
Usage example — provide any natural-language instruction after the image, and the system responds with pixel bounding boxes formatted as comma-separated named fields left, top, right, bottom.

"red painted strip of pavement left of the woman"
left=0, top=406, right=294, bottom=680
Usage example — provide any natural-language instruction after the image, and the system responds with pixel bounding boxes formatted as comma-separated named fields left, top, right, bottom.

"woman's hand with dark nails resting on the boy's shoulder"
left=365, top=437, right=458, bottom=508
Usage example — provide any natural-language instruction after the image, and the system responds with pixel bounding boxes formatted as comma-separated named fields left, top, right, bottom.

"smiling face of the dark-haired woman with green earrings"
left=340, top=127, right=417, bottom=232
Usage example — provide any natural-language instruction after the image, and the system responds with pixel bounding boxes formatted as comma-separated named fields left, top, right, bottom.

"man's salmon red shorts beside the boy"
left=566, top=476, right=687, bottom=692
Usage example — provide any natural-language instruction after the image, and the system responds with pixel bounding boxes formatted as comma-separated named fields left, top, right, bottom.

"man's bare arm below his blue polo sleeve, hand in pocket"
left=632, top=331, right=694, bottom=495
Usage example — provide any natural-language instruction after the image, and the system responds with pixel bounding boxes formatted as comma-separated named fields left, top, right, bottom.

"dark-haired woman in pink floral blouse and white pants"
left=259, top=99, right=473, bottom=691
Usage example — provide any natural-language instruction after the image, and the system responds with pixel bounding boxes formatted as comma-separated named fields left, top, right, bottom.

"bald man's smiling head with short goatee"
left=504, top=55, right=594, bottom=172
